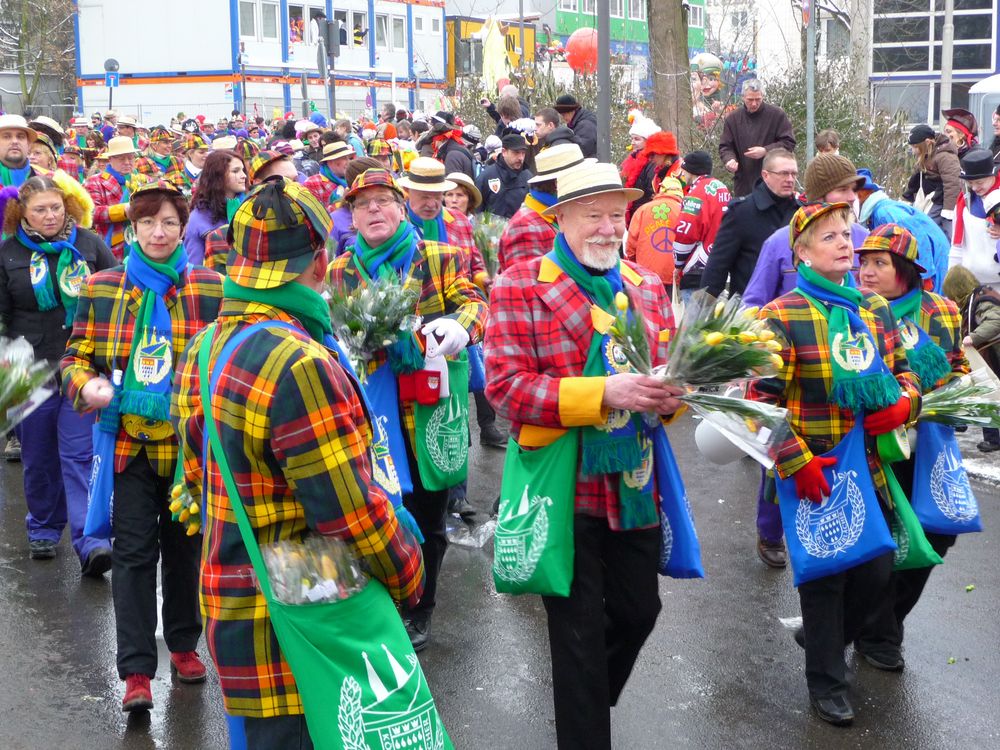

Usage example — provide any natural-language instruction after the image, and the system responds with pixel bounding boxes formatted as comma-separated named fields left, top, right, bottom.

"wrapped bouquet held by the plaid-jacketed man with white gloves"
left=329, top=279, right=420, bottom=381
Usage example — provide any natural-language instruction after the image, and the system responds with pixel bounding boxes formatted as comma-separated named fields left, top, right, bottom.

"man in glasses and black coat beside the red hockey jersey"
left=701, top=149, right=800, bottom=297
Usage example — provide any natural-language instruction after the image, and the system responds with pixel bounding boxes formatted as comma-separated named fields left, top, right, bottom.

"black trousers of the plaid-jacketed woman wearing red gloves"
left=799, top=552, right=893, bottom=698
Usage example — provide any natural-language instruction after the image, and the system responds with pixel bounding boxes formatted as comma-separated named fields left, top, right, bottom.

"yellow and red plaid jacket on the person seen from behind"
left=171, top=300, right=423, bottom=718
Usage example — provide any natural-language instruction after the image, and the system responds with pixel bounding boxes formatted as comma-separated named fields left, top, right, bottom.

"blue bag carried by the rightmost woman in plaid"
left=910, top=420, right=983, bottom=534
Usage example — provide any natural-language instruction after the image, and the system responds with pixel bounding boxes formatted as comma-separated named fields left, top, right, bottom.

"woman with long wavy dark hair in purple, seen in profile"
left=184, top=151, right=247, bottom=266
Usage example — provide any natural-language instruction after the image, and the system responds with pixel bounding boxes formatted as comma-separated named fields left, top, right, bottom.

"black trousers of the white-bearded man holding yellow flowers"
left=542, top=515, right=660, bottom=750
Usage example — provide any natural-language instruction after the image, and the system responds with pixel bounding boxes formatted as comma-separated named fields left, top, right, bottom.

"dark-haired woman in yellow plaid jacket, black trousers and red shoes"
left=61, top=180, right=222, bottom=711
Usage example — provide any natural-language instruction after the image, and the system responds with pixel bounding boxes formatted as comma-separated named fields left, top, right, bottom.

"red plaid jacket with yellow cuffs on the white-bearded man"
left=485, top=257, right=674, bottom=529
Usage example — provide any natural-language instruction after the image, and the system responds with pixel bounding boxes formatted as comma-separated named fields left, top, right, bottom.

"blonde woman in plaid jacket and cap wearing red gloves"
left=749, top=203, right=920, bottom=725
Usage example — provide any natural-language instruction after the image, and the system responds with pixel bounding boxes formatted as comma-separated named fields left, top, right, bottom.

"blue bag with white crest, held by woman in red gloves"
left=776, top=424, right=896, bottom=586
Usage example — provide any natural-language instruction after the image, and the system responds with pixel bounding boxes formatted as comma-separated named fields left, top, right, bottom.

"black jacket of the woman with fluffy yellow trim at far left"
left=0, top=228, right=118, bottom=365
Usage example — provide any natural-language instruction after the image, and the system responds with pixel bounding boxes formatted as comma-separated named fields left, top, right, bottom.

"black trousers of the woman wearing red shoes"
left=111, top=450, right=201, bottom=679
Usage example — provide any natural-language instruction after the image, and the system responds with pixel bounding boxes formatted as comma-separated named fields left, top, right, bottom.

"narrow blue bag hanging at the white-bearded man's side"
left=652, top=425, right=705, bottom=578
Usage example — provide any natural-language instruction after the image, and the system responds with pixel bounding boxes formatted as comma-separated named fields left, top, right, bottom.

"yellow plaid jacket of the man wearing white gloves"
left=327, top=241, right=489, bottom=446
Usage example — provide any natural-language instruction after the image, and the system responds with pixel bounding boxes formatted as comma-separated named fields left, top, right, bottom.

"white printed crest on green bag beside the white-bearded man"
left=493, top=486, right=552, bottom=583
